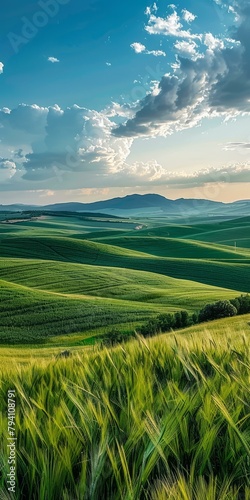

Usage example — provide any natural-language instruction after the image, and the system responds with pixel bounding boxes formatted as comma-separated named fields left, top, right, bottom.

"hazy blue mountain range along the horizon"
left=0, top=194, right=250, bottom=216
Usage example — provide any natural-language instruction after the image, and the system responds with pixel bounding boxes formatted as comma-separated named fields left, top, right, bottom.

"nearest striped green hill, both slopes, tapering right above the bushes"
left=0, top=259, right=237, bottom=343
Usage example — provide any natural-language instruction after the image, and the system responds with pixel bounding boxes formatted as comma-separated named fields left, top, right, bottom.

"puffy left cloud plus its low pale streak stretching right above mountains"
left=0, top=100, right=250, bottom=191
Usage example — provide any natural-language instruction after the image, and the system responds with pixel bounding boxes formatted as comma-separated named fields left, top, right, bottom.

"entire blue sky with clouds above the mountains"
left=0, top=0, right=250, bottom=204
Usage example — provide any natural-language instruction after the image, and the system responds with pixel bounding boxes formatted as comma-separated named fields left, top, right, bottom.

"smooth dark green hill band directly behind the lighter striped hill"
left=1, top=236, right=250, bottom=292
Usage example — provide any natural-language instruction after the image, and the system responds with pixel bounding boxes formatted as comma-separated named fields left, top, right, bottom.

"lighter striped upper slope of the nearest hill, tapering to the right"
left=0, top=259, right=237, bottom=302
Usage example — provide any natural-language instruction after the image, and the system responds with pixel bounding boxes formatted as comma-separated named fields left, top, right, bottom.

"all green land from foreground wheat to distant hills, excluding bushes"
left=0, top=213, right=250, bottom=500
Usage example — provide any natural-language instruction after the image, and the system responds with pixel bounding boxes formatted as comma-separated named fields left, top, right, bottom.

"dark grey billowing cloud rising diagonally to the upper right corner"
left=113, top=0, right=250, bottom=137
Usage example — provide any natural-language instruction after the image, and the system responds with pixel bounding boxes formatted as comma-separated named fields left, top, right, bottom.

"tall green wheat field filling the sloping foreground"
left=0, top=316, right=250, bottom=500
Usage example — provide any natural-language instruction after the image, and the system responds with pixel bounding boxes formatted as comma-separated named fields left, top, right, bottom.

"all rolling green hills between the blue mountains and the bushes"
left=0, top=214, right=250, bottom=344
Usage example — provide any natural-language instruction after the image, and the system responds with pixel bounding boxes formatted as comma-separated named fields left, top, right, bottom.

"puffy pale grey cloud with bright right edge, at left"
left=0, top=105, right=132, bottom=186
